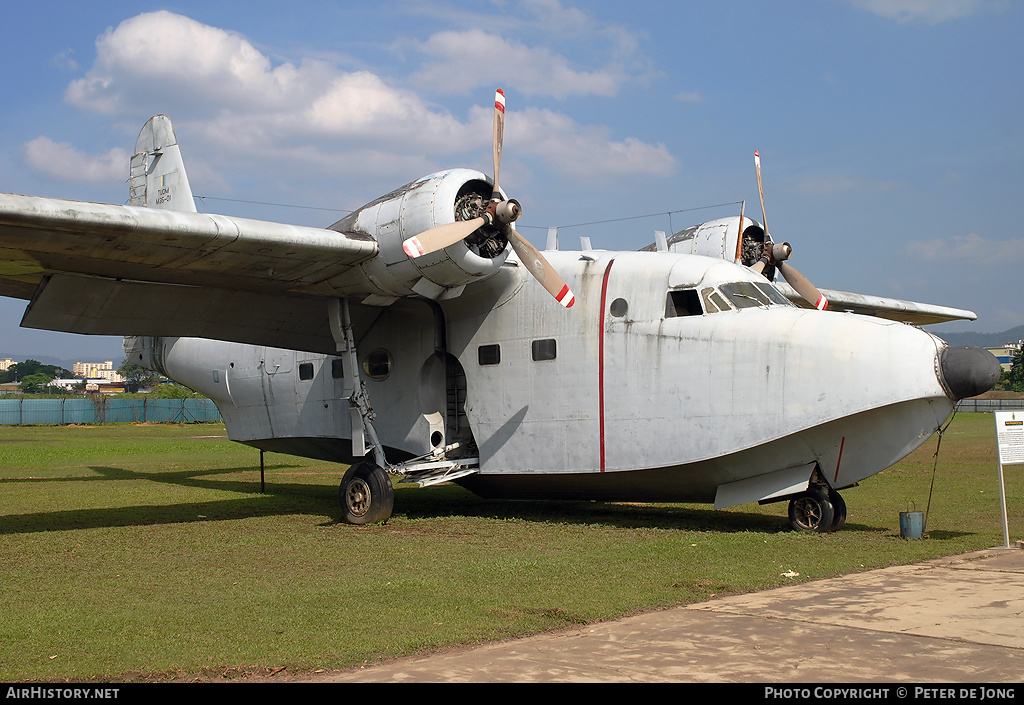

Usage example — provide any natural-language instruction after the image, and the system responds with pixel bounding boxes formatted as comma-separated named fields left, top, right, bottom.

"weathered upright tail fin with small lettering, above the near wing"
left=128, top=115, right=196, bottom=213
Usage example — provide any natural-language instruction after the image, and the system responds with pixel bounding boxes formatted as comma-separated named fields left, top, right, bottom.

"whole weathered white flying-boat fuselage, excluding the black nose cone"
left=134, top=251, right=952, bottom=506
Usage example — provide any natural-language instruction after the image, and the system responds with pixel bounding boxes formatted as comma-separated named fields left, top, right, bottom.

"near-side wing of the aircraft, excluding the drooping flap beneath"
left=0, top=194, right=377, bottom=298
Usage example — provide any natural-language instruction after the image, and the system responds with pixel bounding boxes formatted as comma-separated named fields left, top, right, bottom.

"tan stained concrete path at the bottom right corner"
left=296, top=548, right=1024, bottom=683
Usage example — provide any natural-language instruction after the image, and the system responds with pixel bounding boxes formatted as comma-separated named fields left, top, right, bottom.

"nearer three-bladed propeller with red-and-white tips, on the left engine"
left=402, top=88, right=575, bottom=308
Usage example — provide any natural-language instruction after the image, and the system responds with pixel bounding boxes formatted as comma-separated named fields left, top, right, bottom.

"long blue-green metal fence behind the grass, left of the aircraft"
left=0, top=397, right=220, bottom=426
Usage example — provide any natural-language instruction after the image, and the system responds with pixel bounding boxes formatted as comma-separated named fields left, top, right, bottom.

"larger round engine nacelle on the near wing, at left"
left=331, top=169, right=510, bottom=299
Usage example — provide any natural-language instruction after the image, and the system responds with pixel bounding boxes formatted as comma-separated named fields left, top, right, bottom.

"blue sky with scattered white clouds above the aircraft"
left=0, top=0, right=1024, bottom=359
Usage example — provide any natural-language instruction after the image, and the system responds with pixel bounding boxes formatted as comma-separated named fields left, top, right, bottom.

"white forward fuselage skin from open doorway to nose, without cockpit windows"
left=452, top=253, right=952, bottom=501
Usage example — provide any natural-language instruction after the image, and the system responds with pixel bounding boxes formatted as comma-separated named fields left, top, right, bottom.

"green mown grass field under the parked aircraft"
left=0, top=414, right=1024, bottom=681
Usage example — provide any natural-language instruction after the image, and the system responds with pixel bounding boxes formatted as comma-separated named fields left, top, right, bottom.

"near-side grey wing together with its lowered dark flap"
left=0, top=194, right=379, bottom=350
